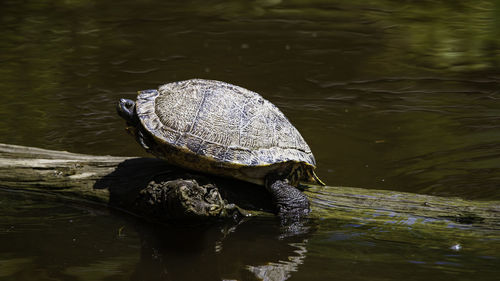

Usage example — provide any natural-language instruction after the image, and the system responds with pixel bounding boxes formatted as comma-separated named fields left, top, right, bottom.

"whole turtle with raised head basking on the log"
left=117, top=79, right=324, bottom=217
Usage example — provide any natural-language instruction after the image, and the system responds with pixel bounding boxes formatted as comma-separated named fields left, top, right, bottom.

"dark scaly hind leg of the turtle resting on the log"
left=266, top=176, right=311, bottom=218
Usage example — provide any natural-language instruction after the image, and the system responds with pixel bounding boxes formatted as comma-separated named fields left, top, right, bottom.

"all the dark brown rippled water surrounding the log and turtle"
left=0, top=0, right=500, bottom=280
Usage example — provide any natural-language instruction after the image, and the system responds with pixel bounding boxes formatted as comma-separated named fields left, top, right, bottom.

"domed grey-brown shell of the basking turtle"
left=136, top=79, right=316, bottom=183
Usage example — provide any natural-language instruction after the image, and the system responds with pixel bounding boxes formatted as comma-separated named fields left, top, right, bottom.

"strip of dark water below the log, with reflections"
left=0, top=192, right=500, bottom=281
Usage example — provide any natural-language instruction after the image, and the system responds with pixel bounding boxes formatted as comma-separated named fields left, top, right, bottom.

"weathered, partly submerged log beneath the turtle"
left=0, top=144, right=500, bottom=231
